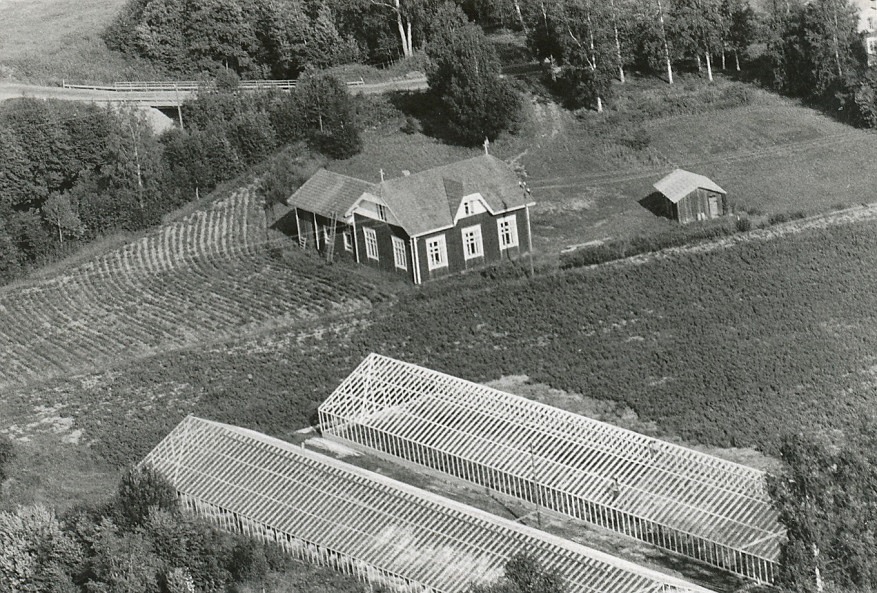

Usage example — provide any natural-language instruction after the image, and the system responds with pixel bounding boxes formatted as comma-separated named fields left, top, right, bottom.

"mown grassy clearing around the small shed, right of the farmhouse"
left=521, top=80, right=877, bottom=253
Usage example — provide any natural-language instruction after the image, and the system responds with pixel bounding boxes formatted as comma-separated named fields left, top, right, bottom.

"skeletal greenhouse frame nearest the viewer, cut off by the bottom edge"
left=141, top=416, right=712, bottom=593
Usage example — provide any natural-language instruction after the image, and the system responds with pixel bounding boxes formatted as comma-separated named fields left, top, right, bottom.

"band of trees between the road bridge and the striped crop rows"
left=0, top=72, right=364, bottom=282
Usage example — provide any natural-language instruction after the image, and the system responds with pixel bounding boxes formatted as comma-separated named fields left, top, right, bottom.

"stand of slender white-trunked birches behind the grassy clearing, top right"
left=524, top=0, right=756, bottom=111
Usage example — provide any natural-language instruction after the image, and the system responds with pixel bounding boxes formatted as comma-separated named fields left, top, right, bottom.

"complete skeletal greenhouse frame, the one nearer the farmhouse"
left=319, top=354, right=785, bottom=582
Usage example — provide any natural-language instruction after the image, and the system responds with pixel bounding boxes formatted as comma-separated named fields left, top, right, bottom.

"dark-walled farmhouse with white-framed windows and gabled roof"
left=287, top=154, right=533, bottom=284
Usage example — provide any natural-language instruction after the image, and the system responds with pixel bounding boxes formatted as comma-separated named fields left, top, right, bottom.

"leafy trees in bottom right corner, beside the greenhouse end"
left=768, top=430, right=877, bottom=593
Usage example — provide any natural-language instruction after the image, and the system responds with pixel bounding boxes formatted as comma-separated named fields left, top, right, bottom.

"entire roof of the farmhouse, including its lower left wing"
left=287, top=155, right=529, bottom=236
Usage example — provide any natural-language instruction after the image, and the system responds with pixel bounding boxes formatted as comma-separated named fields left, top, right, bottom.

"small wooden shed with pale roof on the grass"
left=654, top=169, right=727, bottom=224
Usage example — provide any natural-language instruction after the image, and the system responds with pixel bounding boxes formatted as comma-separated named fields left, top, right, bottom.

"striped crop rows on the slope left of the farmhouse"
left=0, top=189, right=367, bottom=388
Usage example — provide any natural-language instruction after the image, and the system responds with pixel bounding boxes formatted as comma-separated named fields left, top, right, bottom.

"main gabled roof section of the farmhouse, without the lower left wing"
left=377, top=155, right=529, bottom=236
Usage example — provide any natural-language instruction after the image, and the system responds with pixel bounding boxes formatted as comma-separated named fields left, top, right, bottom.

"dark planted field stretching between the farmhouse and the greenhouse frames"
left=0, top=204, right=877, bottom=502
